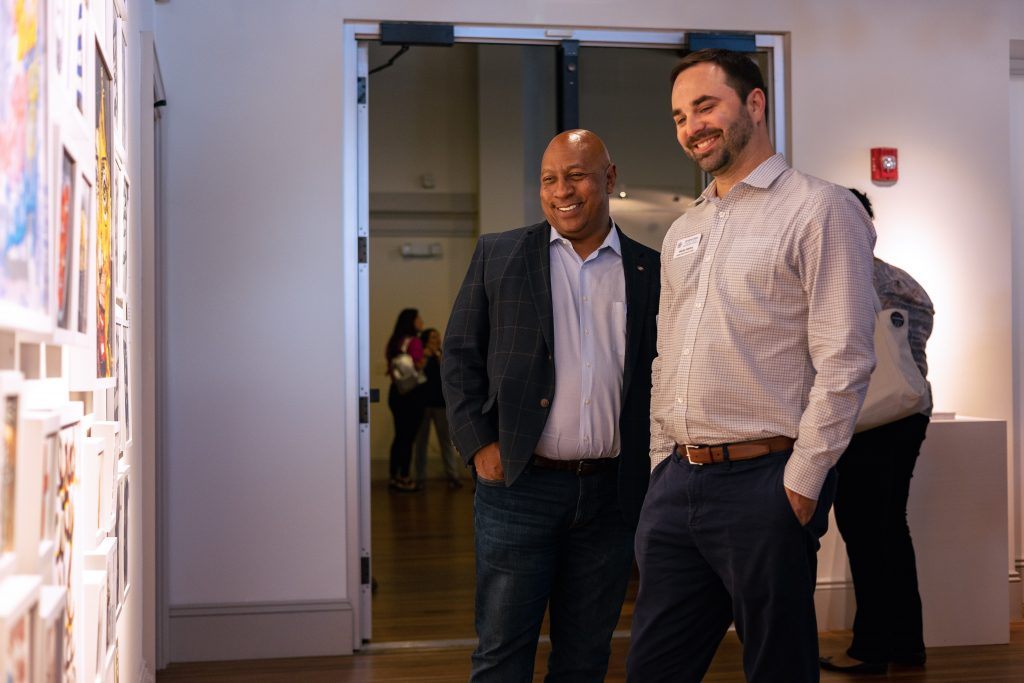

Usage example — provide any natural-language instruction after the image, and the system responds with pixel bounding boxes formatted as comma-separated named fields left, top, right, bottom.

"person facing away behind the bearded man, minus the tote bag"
left=821, top=188, right=935, bottom=674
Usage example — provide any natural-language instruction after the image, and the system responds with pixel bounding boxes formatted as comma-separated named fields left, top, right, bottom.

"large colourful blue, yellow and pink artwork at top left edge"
left=0, top=0, right=49, bottom=316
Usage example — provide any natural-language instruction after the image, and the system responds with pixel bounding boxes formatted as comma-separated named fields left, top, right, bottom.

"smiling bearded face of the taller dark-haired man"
left=672, top=62, right=764, bottom=180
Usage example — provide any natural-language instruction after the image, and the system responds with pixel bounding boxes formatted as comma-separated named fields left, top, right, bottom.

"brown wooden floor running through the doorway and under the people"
left=157, top=479, right=1024, bottom=683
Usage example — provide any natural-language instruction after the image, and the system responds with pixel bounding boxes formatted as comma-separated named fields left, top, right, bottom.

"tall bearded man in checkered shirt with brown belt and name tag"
left=628, top=50, right=874, bottom=683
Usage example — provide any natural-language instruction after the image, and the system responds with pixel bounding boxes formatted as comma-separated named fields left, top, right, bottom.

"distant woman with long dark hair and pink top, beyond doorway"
left=385, top=308, right=426, bottom=494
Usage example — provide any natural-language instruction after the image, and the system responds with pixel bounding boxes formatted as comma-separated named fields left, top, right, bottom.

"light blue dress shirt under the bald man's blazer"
left=537, top=224, right=626, bottom=460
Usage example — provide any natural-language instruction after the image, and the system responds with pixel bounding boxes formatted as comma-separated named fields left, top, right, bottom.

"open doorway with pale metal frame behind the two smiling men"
left=344, top=25, right=786, bottom=648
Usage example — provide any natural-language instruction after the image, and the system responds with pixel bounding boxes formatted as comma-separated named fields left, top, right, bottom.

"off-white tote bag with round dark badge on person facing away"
left=854, top=308, right=931, bottom=432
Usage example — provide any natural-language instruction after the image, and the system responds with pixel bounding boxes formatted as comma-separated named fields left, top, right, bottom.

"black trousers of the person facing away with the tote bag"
left=836, top=415, right=929, bottom=664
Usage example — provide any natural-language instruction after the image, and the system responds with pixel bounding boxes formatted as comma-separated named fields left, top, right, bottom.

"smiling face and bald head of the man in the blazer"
left=541, top=130, right=615, bottom=257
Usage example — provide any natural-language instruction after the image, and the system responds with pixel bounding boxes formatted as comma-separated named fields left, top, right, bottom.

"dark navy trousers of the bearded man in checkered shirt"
left=627, top=452, right=836, bottom=683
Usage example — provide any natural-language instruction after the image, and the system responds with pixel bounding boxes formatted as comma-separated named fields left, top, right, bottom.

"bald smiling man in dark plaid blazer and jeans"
left=441, top=130, right=659, bottom=683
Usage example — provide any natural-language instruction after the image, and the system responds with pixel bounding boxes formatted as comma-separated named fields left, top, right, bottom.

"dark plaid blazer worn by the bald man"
left=441, top=222, right=660, bottom=524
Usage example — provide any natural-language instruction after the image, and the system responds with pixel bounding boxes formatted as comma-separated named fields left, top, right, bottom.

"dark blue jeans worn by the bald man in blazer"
left=470, top=466, right=633, bottom=683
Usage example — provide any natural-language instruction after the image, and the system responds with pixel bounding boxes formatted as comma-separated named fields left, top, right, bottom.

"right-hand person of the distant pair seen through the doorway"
left=415, top=328, right=462, bottom=489
